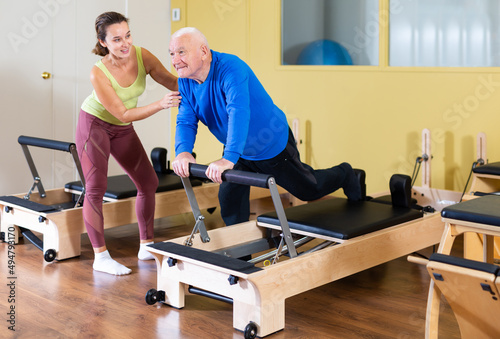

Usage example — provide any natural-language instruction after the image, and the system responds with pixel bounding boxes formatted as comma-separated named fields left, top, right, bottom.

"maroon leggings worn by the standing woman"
left=76, top=111, right=158, bottom=248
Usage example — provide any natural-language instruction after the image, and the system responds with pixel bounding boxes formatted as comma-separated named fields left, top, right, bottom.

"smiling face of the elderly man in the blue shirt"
left=170, top=34, right=205, bottom=81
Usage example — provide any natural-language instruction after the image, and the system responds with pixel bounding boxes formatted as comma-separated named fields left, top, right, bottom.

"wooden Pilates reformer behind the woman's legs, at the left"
left=0, top=136, right=282, bottom=262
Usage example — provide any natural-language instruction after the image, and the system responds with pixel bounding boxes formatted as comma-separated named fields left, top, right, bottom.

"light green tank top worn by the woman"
left=81, top=46, right=147, bottom=125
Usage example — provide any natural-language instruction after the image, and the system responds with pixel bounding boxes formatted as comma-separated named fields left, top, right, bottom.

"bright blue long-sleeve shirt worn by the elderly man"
left=175, top=51, right=288, bottom=163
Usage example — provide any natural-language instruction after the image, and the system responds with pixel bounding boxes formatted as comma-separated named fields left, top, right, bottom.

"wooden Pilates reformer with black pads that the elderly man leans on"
left=145, top=164, right=443, bottom=338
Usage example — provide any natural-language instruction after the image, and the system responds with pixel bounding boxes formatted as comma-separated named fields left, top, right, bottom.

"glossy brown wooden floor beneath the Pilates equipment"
left=0, top=199, right=460, bottom=339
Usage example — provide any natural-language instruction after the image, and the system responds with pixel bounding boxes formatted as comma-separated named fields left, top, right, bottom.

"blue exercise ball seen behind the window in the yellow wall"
left=297, top=39, right=352, bottom=65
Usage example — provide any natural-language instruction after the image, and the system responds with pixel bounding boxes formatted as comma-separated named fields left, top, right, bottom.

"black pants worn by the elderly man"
left=219, top=131, right=353, bottom=226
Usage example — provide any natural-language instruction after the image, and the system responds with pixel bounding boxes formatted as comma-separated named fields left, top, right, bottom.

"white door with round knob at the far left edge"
left=0, top=0, right=53, bottom=195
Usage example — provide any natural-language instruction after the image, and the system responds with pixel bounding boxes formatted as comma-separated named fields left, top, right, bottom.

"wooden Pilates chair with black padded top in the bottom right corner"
left=425, top=195, right=500, bottom=339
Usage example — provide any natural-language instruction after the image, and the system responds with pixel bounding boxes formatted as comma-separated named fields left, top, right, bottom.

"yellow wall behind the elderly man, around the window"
left=172, top=0, right=500, bottom=193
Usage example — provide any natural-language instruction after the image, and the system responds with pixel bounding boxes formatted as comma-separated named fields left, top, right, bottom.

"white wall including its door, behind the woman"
left=0, top=0, right=174, bottom=195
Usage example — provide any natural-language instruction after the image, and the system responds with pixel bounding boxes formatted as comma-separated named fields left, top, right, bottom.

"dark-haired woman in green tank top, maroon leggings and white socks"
left=76, top=12, right=181, bottom=275
